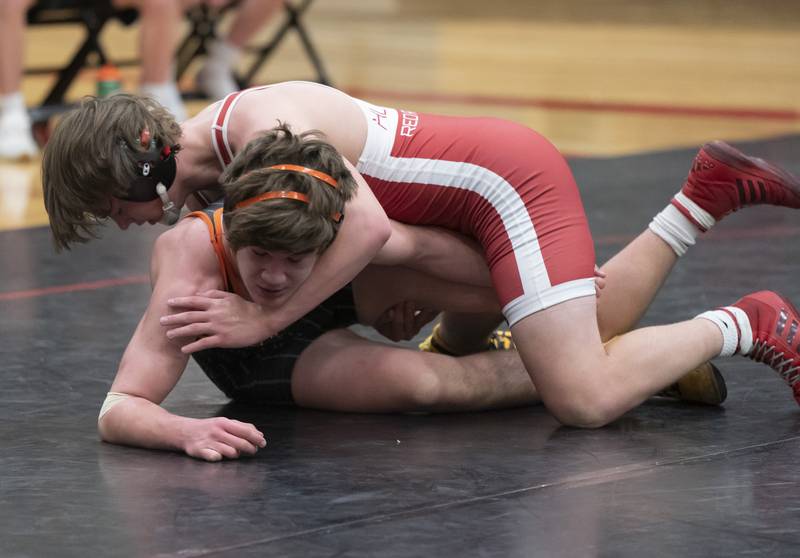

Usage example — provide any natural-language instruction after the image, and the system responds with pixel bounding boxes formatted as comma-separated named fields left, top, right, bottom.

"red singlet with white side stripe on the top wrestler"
left=211, top=86, right=595, bottom=325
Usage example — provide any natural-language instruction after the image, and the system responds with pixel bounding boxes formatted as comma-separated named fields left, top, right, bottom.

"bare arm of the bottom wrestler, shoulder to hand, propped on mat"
left=98, top=219, right=264, bottom=461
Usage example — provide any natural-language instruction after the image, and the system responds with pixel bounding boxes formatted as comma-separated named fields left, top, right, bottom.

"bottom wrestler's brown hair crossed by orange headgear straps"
left=220, top=123, right=357, bottom=254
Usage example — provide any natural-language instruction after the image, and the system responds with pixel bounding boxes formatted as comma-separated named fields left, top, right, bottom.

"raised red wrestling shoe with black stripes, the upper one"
left=672, top=141, right=800, bottom=232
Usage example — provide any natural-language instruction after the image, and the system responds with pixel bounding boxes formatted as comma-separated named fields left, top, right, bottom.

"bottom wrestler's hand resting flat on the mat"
left=181, top=417, right=267, bottom=461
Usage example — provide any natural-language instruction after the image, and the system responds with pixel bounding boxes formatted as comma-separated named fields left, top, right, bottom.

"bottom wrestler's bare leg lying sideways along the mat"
left=292, top=330, right=538, bottom=412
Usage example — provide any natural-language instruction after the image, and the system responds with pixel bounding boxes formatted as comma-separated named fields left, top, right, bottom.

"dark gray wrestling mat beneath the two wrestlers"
left=0, top=137, right=800, bottom=558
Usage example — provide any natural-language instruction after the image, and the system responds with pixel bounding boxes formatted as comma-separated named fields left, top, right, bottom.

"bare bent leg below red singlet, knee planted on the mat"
left=511, top=297, right=723, bottom=427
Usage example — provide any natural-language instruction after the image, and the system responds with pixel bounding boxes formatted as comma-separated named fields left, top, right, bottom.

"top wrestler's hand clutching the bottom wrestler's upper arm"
left=160, top=290, right=270, bottom=354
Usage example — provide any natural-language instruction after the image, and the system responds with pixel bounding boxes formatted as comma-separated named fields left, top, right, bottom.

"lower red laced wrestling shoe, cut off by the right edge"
left=723, top=291, right=800, bottom=405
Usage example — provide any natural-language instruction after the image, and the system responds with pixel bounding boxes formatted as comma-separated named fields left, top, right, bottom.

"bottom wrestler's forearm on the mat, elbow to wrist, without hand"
left=97, top=396, right=191, bottom=451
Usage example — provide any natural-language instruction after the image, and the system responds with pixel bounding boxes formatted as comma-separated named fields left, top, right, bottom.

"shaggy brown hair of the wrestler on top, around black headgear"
left=42, top=93, right=181, bottom=251
